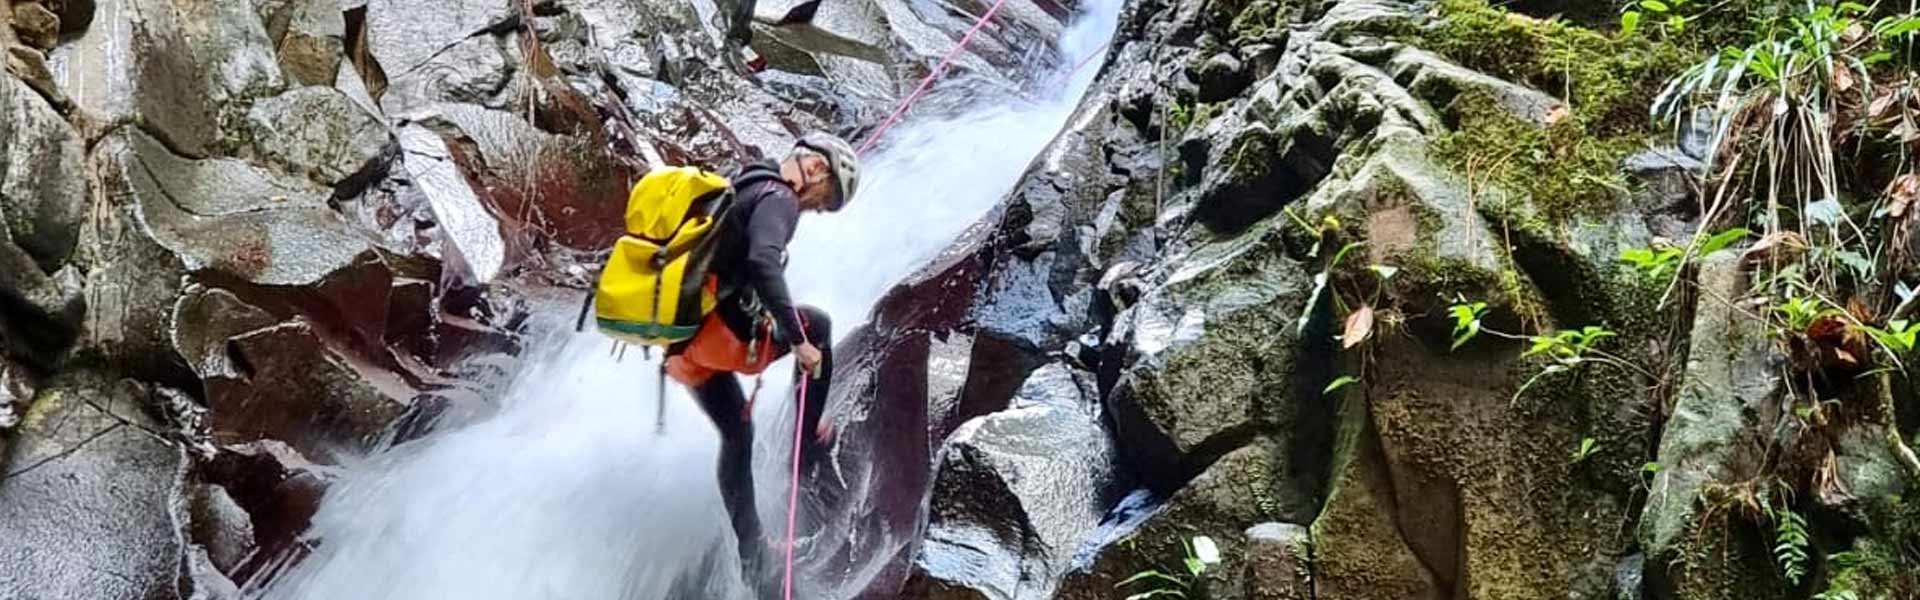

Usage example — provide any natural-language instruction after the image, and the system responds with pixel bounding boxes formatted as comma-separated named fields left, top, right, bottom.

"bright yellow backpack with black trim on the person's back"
left=582, top=167, right=733, bottom=346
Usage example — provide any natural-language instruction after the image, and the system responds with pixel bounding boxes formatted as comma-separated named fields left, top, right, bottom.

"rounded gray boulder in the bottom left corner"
left=0, top=371, right=188, bottom=598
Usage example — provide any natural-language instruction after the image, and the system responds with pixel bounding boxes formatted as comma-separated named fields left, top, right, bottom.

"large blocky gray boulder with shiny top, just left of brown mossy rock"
left=1108, top=221, right=1313, bottom=490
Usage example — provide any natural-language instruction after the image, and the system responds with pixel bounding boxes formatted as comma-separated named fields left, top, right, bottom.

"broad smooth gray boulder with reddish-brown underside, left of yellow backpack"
left=86, top=131, right=432, bottom=388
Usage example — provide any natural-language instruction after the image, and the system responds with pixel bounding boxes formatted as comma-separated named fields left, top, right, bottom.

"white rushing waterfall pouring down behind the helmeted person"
left=248, top=0, right=1121, bottom=600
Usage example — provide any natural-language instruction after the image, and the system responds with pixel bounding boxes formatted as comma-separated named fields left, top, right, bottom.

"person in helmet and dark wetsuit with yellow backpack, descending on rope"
left=582, top=133, right=860, bottom=587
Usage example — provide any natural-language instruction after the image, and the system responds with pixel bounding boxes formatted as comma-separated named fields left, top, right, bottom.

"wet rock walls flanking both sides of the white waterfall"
left=0, top=0, right=1920, bottom=598
